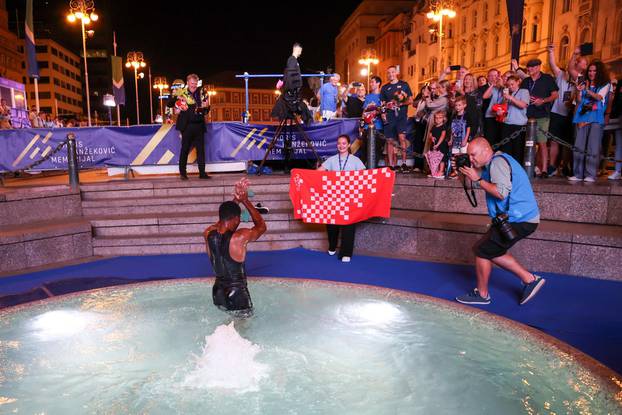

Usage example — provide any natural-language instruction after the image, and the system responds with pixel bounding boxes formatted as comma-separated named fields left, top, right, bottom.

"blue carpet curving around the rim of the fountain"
left=0, top=248, right=622, bottom=373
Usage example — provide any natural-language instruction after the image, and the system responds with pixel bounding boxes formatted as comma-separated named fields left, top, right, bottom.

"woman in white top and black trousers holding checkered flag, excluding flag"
left=318, top=134, right=365, bottom=262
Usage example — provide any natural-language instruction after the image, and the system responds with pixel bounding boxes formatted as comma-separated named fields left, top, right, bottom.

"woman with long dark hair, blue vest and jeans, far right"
left=568, top=61, right=611, bottom=183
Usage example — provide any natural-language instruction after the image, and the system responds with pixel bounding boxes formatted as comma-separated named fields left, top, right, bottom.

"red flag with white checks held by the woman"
left=289, top=168, right=395, bottom=225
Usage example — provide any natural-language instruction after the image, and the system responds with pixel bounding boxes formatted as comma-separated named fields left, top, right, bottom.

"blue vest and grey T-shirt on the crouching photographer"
left=482, top=152, right=540, bottom=223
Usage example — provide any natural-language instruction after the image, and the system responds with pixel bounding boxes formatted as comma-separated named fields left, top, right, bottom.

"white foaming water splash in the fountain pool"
left=184, top=322, right=270, bottom=393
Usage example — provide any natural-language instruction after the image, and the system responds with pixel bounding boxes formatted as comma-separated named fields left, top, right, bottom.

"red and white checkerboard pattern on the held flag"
left=297, top=168, right=391, bottom=225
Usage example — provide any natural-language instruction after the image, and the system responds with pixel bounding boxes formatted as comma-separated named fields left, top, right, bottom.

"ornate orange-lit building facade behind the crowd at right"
left=335, top=0, right=622, bottom=92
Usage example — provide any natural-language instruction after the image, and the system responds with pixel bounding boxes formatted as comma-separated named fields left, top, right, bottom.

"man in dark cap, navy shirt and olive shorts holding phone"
left=521, top=59, right=559, bottom=178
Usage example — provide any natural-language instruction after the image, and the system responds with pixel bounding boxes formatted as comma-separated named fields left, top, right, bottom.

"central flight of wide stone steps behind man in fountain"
left=81, top=176, right=327, bottom=256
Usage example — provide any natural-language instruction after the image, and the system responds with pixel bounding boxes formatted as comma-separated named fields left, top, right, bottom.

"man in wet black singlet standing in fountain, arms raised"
left=203, top=178, right=266, bottom=318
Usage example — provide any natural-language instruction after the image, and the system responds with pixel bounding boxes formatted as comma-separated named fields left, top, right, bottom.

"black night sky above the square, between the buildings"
left=7, top=0, right=360, bottom=83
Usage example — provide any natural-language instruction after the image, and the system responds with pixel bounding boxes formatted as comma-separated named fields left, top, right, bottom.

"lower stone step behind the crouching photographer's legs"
left=355, top=211, right=622, bottom=280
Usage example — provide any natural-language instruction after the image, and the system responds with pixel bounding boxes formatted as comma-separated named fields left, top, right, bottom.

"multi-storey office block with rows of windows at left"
left=24, top=39, right=83, bottom=116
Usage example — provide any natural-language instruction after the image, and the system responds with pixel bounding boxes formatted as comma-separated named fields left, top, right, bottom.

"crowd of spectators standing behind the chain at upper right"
left=312, top=45, right=622, bottom=182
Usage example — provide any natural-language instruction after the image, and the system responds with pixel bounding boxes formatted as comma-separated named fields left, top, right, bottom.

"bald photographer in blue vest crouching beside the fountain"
left=454, top=137, right=545, bottom=305
